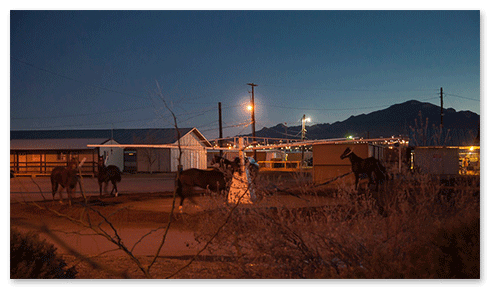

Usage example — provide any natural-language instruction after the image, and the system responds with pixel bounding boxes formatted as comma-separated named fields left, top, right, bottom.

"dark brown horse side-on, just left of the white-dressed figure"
left=176, top=168, right=229, bottom=211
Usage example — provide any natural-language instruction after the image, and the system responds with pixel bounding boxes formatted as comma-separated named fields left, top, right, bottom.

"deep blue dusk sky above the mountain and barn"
left=10, top=10, right=480, bottom=139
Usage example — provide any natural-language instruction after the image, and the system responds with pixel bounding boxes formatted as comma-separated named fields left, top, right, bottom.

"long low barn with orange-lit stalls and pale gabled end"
left=10, top=128, right=211, bottom=175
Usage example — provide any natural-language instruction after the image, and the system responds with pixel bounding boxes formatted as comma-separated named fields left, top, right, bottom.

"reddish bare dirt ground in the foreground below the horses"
left=10, top=182, right=332, bottom=279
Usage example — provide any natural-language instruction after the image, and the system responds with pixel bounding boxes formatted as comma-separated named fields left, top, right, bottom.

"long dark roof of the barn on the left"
left=10, top=128, right=211, bottom=146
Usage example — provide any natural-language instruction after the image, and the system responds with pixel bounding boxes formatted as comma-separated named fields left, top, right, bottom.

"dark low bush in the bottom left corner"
left=10, top=228, right=77, bottom=279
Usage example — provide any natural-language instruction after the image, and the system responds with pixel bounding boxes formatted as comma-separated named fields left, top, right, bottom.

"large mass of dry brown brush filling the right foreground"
left=190, top=170, right=480, bottom=279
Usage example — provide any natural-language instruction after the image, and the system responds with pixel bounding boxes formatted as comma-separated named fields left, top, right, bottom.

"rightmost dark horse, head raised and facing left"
left=340, top=148, right=386, bottom=191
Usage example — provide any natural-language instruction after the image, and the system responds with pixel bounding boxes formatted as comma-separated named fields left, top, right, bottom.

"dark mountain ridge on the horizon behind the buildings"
left=243, top=100, right=480, bottom=145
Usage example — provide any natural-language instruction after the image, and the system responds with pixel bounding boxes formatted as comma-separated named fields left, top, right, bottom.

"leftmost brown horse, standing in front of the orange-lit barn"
left=51, top=160, right=78, bottom=206
